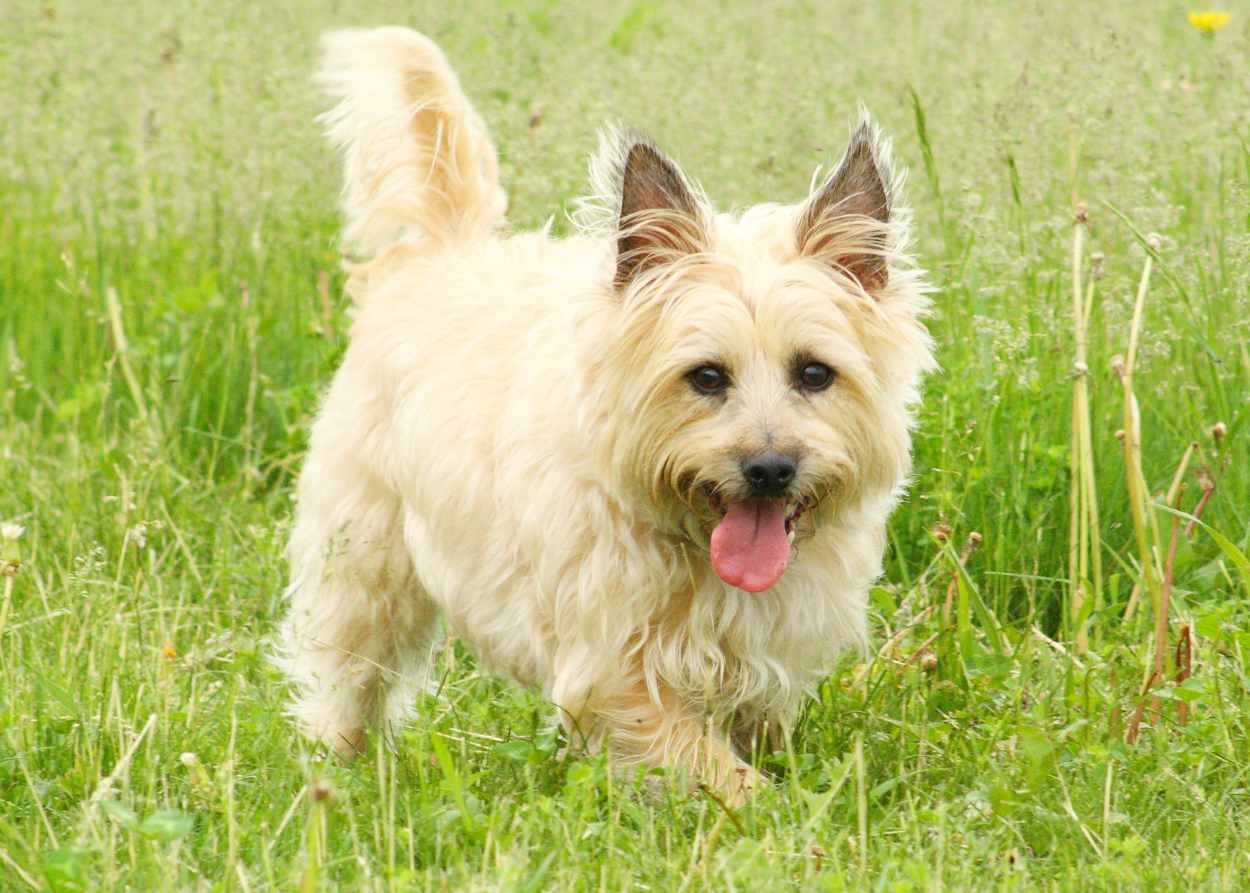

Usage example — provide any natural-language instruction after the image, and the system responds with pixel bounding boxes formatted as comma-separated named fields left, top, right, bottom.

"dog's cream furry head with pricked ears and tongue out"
left=580, top=120, right=933, bottom=592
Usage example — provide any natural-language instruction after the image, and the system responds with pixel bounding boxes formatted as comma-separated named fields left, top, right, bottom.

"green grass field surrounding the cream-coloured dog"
left=0, top=0, right=1250, bottom=890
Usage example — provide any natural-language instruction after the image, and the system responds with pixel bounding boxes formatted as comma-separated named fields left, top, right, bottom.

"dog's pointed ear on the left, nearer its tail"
left=593, top=133, right=708, bottom=289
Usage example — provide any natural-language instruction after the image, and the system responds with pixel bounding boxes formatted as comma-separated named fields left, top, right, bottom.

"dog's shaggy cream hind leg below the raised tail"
left=279, top=438, right=438, bottom=757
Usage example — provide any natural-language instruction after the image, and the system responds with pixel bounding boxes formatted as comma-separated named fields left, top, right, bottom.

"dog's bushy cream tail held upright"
left=318, top=28, right=508, bottom=258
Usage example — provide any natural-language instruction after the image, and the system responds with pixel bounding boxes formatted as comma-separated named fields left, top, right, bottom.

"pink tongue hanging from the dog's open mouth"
left=711, top=499, right=790, bottom=593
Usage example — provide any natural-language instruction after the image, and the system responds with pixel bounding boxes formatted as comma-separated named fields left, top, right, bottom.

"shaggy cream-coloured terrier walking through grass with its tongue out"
left=279, top=28, right=934, bottom=803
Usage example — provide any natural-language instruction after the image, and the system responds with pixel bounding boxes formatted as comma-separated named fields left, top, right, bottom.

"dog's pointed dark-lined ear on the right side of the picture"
left=795, top=118, right=893, bottom=295
